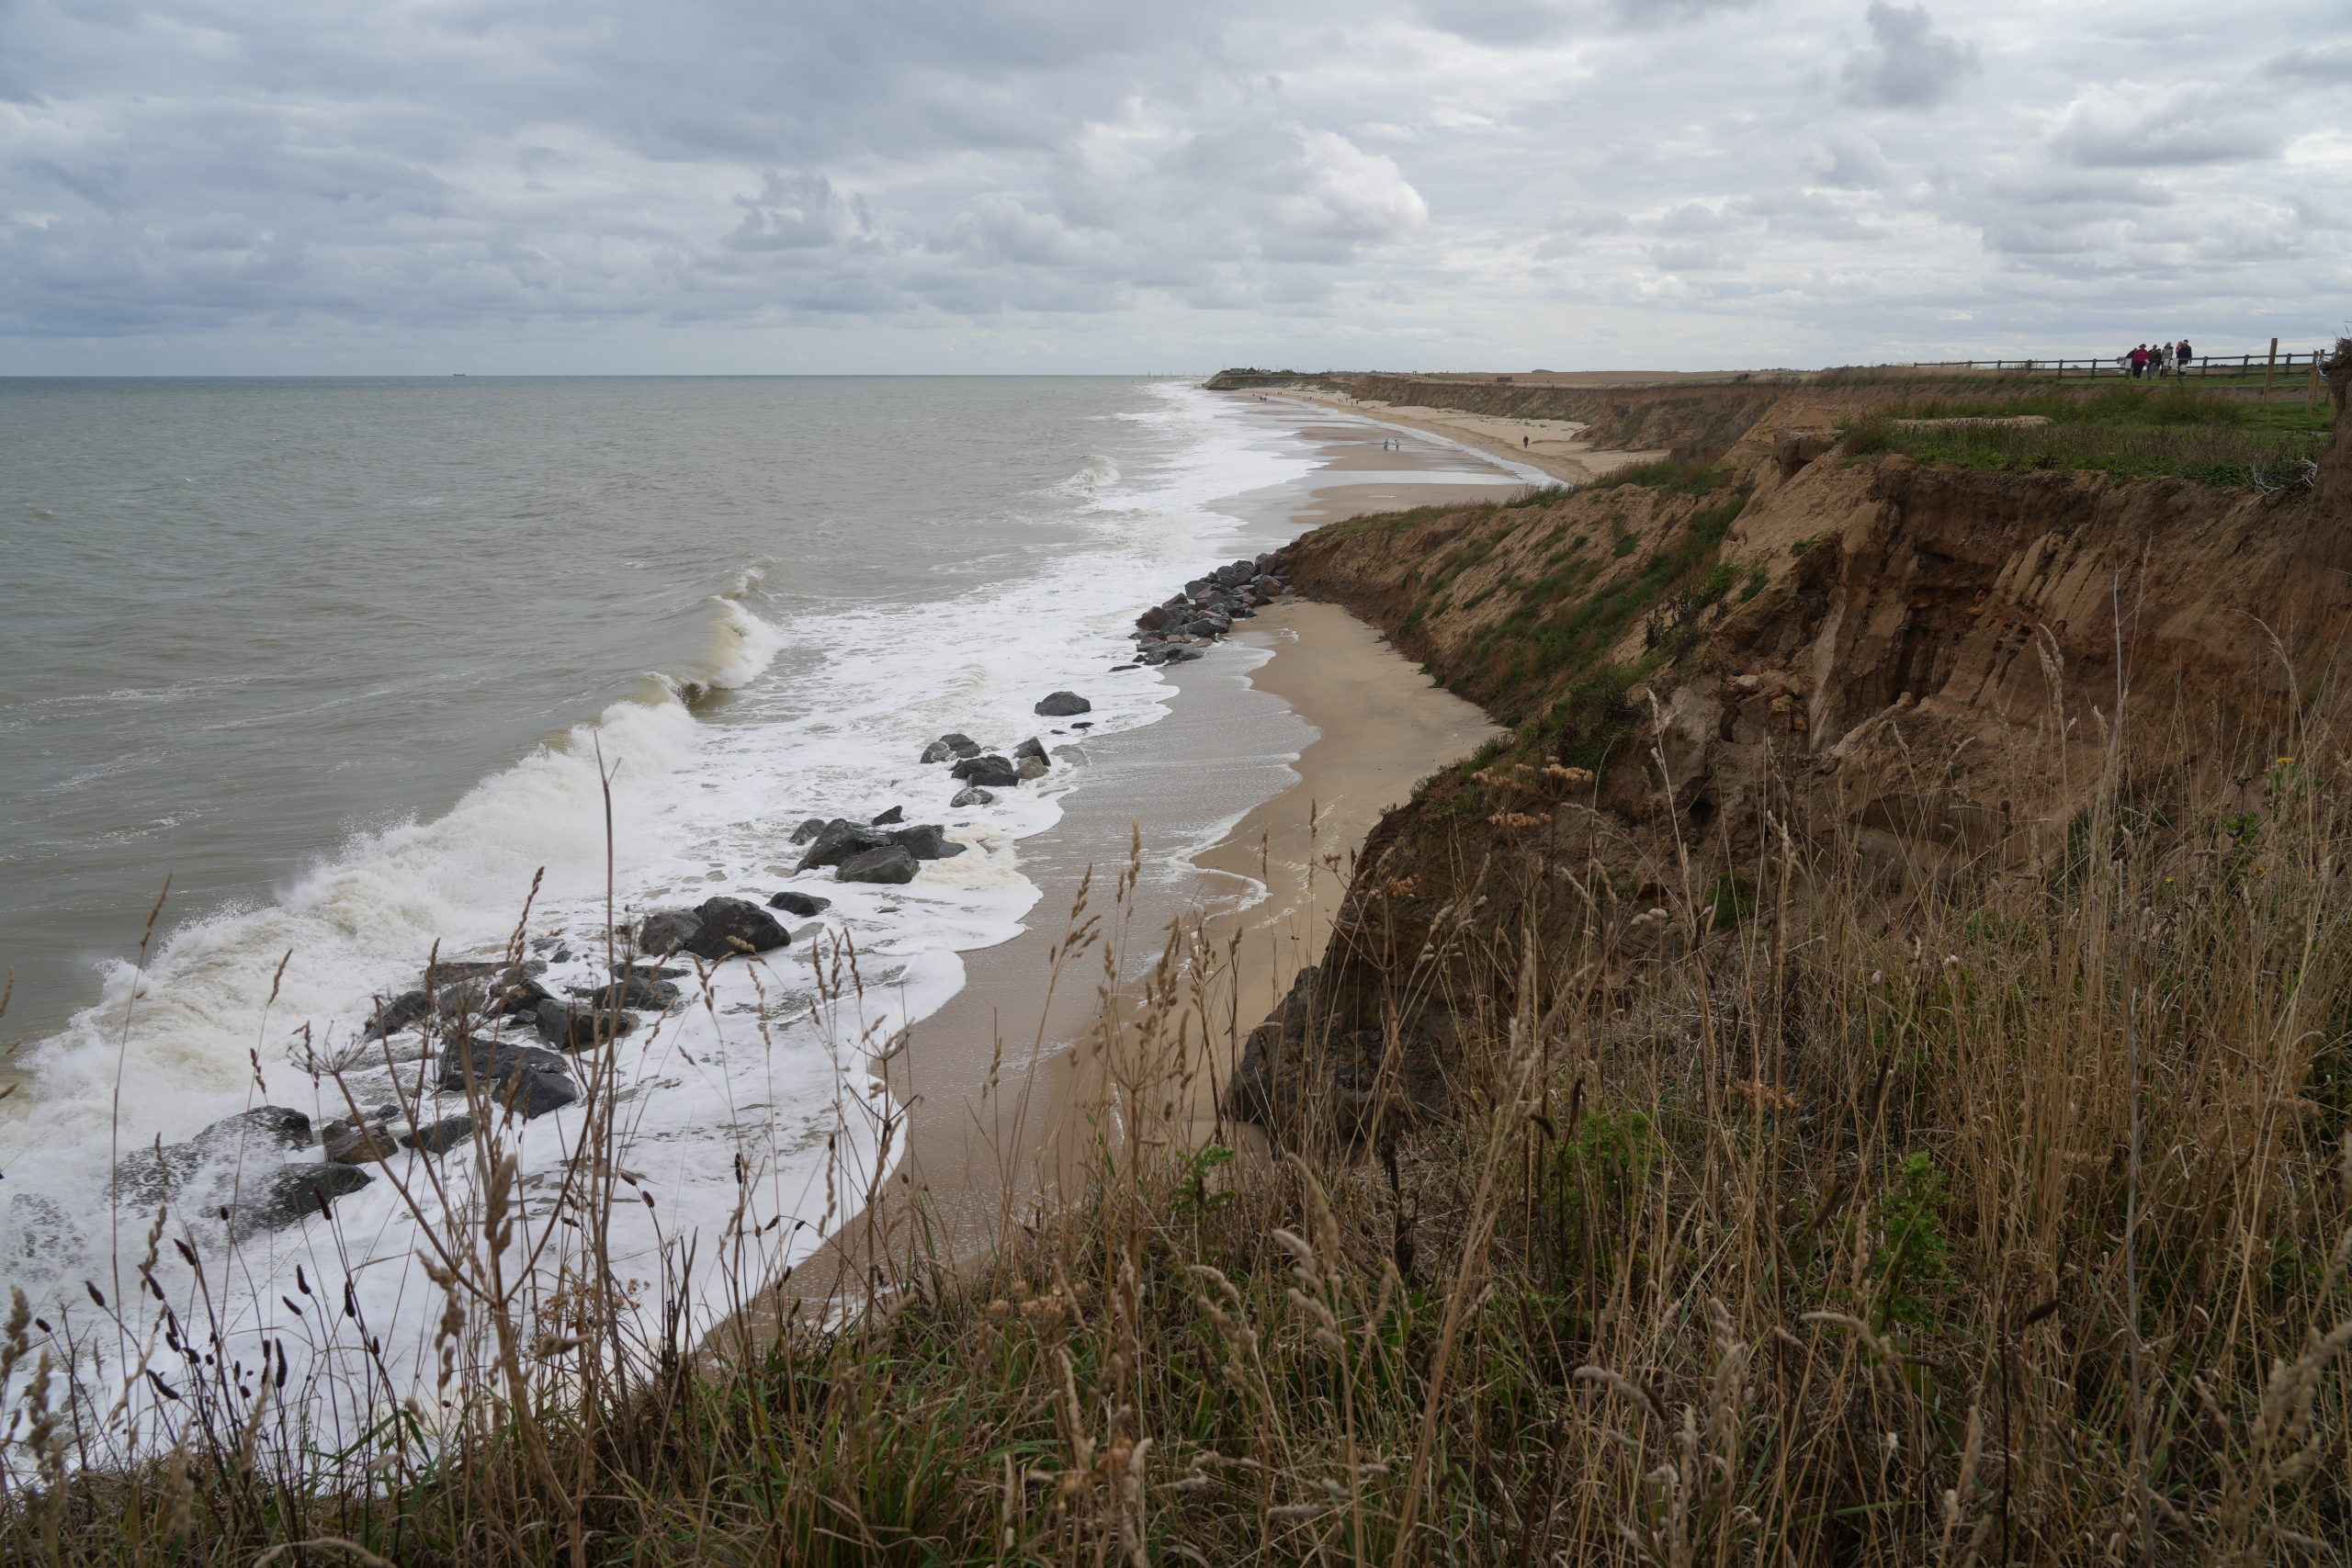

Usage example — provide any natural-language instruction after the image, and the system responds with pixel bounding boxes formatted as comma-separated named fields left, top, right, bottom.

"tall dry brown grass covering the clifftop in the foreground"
left=0, top=691, right=2352, bottom=1568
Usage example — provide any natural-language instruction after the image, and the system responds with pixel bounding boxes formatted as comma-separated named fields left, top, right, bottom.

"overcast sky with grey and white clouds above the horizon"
left=0, top=0, right=2352, bottom=374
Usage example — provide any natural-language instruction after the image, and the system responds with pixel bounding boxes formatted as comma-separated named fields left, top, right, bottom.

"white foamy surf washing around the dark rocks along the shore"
left=0, top=386, right=1312, bottom=1437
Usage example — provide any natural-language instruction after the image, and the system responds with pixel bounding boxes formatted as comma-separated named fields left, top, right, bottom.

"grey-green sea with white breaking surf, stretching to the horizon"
left=0, top=378, right=1491, bottom=1425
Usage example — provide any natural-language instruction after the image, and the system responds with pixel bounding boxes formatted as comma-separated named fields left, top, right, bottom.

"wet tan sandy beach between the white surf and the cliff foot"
left=771, top=409, right=1524, bottom=1300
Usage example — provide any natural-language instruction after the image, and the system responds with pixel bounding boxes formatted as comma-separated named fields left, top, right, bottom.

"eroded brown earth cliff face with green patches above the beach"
left=1232, top=404, right=2352, bottom=1135
